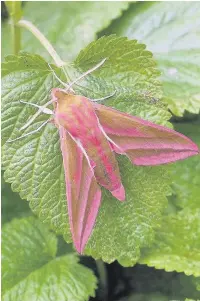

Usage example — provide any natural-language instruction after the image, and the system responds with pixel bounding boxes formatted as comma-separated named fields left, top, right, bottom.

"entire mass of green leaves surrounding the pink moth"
left=2, top=1, right=200, bottom=301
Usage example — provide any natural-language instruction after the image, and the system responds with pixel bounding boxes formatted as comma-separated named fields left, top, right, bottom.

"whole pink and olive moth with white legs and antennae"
left=10, top=59, right=199, bottom=253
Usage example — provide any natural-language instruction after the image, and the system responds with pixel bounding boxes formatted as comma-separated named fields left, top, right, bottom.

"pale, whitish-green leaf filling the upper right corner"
left=106, top=1, right=200, bottom=116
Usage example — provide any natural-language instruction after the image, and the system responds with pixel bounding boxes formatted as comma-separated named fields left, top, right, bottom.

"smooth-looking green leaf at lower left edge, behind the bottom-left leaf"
left=2, top=217, right=57, bottom=292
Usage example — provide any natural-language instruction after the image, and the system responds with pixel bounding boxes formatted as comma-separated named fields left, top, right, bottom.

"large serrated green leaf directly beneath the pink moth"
left=2, top=36, right=170, bottom=265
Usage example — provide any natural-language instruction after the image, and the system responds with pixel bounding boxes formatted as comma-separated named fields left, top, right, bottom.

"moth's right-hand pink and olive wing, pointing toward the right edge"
left=94, top=104, right=199, bottom=165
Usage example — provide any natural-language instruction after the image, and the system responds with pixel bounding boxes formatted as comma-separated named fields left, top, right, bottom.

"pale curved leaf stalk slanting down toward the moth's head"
left=17, top=20, right=66, bottom=67
